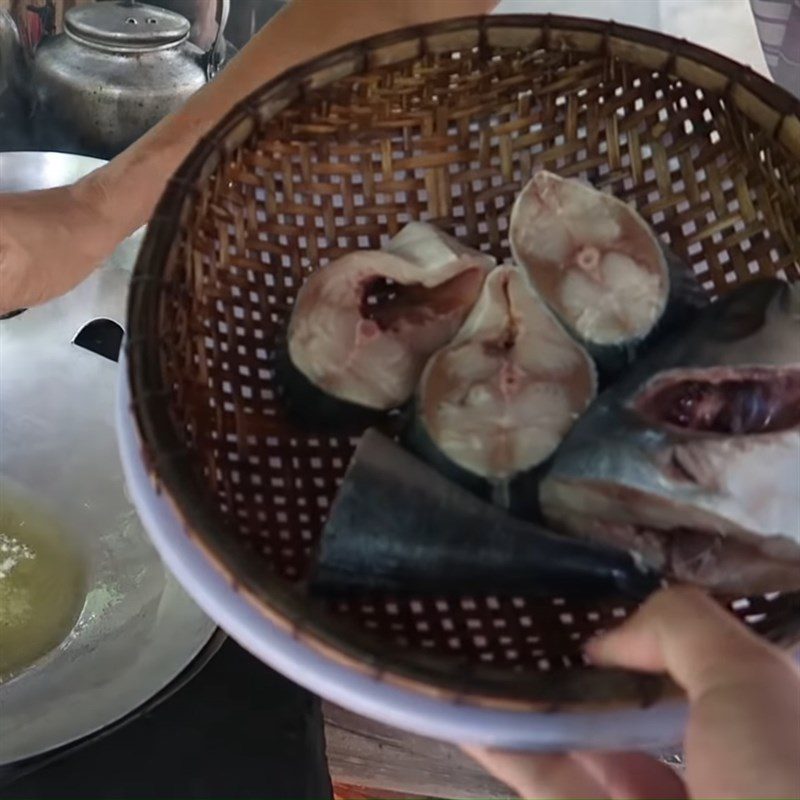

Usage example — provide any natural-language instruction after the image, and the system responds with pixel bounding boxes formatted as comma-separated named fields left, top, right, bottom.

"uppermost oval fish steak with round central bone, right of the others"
left=509, top=170, right=703, bottom=372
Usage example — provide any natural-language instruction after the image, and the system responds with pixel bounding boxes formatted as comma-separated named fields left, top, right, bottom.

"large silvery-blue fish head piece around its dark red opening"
left=540, top=279, right=800, bottom=592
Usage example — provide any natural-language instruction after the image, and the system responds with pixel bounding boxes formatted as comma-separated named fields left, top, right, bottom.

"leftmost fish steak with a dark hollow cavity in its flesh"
left=287, top=222, right=496, bottom=410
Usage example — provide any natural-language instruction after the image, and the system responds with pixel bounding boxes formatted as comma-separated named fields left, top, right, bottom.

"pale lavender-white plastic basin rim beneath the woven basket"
left=117, top=358, right=687, bottom=753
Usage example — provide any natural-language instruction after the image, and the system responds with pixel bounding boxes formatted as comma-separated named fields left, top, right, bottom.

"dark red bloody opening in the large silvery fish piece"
left=635, top=370, right=800, bottom=435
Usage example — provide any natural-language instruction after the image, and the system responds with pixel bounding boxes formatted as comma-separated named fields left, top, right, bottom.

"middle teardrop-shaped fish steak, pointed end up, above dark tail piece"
left=415, top=265, right=596, bottom=505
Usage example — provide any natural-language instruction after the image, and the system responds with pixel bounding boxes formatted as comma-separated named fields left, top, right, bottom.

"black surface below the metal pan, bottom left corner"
left=0, top=639, right=332, bottom=800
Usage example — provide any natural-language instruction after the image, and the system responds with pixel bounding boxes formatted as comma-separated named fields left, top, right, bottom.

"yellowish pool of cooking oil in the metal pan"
left=0, top=482, right=86, bottom=683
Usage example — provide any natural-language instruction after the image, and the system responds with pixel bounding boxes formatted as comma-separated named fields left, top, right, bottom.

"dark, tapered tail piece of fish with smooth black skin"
left=310, top=429, right=661, bottom=599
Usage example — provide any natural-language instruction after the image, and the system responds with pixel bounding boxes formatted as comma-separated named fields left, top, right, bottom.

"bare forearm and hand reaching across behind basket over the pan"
left=0, top=0, right=497, bottom=314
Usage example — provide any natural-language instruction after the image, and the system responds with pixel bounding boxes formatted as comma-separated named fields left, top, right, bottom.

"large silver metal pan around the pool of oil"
left=0, top=153, right=215, bottom=766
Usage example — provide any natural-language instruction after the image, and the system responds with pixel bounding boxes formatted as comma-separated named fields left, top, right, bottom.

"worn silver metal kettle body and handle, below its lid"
left=0, top=0, right=230, bottom=156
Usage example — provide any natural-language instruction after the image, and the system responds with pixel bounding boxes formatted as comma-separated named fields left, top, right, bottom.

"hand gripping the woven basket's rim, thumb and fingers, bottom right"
left=467, top=588, right=800, bottom=799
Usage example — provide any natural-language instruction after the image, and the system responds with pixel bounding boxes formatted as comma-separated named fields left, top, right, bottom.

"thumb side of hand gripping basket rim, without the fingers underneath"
left=586, top=588, right=800, bottom=797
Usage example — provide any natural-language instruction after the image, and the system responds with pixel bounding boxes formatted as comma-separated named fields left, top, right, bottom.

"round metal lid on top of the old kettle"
left=64, top=0, right=191, bottom=50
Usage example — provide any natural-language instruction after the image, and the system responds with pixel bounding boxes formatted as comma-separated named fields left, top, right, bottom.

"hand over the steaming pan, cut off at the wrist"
left=0, top=181, right=124, bottom=314
